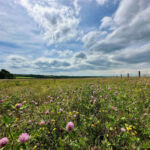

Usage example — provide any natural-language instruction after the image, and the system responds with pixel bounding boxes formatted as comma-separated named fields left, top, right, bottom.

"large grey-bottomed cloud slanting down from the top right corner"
left=84, top=0, right=150, bottom=53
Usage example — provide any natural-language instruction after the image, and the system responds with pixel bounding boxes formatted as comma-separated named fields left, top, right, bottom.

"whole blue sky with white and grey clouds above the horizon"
left=0, top=0, right=150, bottom=76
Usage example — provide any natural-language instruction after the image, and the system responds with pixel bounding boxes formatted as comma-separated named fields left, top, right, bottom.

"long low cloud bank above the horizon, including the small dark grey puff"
left=4, top=52, right=117, bottom=74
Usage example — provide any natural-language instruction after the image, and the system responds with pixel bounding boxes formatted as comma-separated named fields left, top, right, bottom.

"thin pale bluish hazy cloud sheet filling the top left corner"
left=0, top=0, right=43, bottom=51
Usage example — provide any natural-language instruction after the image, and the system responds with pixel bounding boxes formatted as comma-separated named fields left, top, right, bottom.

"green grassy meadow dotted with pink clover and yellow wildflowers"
left=0, top=78, right=150, bottom=150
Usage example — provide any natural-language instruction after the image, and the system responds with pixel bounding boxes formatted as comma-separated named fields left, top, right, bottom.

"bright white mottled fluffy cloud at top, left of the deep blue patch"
left=20, top=0, right=80, bottom=44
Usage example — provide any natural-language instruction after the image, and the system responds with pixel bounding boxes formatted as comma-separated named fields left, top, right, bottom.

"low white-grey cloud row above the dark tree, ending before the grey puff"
left=1, top=55, right=71, bottom=74
